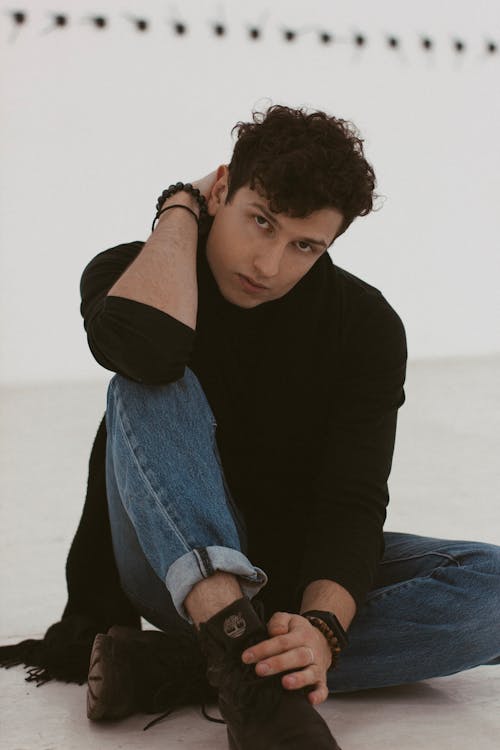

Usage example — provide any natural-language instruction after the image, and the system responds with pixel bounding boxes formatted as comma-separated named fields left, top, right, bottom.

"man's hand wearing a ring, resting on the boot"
left=242, top=612, right=332, bottom=705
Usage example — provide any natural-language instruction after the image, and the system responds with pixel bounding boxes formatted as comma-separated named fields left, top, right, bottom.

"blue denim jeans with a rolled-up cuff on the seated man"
left=106, top=368, right=500, bottom=693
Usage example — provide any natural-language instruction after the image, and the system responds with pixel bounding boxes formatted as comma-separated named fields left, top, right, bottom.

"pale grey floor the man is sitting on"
left=0, top=356, right=500, bottom=750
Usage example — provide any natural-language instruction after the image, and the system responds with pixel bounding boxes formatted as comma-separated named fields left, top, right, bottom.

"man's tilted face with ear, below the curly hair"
left=206, top=165, right=343, bottom=308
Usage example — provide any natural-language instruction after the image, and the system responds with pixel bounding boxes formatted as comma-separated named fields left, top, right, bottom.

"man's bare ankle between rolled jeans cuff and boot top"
left=184, top=570, right=243, bottom=630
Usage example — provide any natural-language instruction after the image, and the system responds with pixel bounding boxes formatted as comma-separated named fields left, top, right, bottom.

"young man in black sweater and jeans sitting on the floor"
left=1, top=106, right=500, bottom=750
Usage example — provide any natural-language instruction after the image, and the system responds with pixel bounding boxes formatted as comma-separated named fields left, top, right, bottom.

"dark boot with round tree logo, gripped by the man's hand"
left=194, top=596, right=340, bottom=750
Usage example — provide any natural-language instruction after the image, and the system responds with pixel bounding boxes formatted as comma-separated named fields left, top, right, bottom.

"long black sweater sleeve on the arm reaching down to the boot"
left=296, top=295, right=407, bottom=609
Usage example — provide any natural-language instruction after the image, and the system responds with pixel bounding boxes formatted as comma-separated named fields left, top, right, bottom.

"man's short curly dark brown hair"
left=226, top=104, right=375, bottom=236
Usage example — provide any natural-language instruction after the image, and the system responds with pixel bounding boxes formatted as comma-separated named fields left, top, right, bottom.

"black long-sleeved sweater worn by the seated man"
left=81, top=229, right=407, bottom=624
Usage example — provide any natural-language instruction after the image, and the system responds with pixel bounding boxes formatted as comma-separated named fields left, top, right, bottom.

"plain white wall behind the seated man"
left=0, top=0, right=500, bottom=383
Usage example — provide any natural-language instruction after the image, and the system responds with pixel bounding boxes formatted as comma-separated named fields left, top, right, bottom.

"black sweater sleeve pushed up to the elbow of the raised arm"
left=80, top=242, right=196, bottom=385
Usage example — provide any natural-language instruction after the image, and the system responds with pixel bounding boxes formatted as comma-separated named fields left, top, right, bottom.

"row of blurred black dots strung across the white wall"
left=4, top=10, right=498, bottom=55
